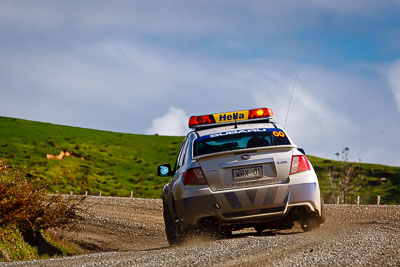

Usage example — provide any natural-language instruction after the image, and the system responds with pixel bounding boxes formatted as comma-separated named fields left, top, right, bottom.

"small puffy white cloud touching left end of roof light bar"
left=146, top=107, right=189, bottom=136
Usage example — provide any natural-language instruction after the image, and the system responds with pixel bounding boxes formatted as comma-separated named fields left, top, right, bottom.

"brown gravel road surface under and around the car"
left=0, top=197, right=400, bottom=266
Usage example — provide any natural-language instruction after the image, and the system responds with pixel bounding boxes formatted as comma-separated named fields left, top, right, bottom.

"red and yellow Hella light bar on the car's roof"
left=189, top=108, right=274, bottom=128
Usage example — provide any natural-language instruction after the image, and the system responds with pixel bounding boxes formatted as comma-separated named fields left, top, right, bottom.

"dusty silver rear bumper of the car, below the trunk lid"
left=175, top=179, right=321, bottom=228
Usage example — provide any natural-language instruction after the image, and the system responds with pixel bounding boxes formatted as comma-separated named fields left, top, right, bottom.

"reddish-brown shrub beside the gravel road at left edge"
left=0, top=159, right=84, bottom=235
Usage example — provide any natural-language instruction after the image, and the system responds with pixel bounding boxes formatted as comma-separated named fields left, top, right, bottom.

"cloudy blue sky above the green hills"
left=0, top=0, right=400, bottom=166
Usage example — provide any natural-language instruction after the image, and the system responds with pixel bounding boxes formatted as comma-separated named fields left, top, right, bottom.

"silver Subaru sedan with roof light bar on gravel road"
left=158, top=108, right=325, bottom=245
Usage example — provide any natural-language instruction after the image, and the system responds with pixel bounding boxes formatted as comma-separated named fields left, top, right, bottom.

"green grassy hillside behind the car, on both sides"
left=0, top=117, right=400, bottom=204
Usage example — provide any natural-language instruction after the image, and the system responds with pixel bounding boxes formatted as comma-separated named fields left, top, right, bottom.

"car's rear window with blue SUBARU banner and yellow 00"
left=193, top=128, right=290, bottom=156
